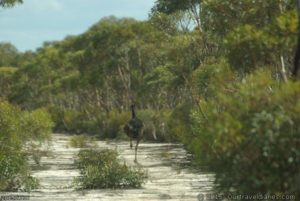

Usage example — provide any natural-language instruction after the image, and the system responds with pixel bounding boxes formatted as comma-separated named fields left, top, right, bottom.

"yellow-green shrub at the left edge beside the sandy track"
left=0, top=100, right=52, bottom=191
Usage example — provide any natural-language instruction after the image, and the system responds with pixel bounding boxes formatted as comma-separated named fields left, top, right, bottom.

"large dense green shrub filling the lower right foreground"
left=188, top=72, right=300, bottom=199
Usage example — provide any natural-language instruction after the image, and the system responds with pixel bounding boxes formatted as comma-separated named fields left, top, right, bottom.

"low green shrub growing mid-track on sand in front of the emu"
left=75, top=149, right=146, bottom=189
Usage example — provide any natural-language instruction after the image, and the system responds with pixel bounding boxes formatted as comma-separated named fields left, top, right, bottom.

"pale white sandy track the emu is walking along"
left=0, top=134, right=214, bottom=201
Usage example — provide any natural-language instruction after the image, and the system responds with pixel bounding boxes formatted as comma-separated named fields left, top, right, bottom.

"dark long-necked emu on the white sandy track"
left=124, top=105, right=144, bottom=162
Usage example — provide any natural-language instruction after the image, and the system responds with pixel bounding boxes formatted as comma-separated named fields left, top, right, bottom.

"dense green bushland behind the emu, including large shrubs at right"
left=0, top=0, right=300, bottom=200
